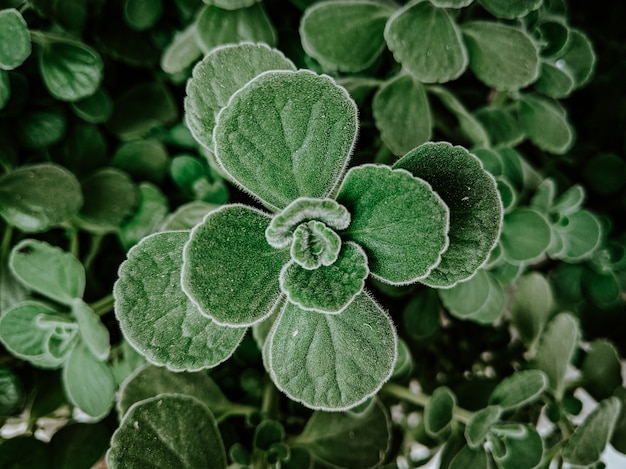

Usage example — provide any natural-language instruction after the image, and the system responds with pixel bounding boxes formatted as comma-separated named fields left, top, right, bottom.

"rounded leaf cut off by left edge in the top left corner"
left=0, top=8, right=32, bottom=70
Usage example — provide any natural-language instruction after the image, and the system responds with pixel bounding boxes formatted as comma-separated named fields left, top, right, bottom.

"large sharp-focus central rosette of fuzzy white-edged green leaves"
left=115, top=44, right=501, bottom=410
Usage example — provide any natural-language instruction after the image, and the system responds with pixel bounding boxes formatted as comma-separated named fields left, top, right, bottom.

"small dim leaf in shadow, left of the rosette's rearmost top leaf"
left=112, top=140, right=169, bottom=184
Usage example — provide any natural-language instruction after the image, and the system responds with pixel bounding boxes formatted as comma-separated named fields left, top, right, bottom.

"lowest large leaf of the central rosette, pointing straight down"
left=264, top=293, right=397, bottom=410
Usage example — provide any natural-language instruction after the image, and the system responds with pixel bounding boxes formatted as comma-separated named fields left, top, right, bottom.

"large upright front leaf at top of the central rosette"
left=214, top=70, right=358, bottom=208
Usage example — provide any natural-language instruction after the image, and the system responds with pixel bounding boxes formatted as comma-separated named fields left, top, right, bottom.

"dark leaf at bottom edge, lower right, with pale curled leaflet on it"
left=488, top=423, right=543, bottom=469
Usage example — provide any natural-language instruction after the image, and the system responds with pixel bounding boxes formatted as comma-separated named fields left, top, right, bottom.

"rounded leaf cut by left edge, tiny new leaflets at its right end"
left=0, top=301, right=78, bottom=368
